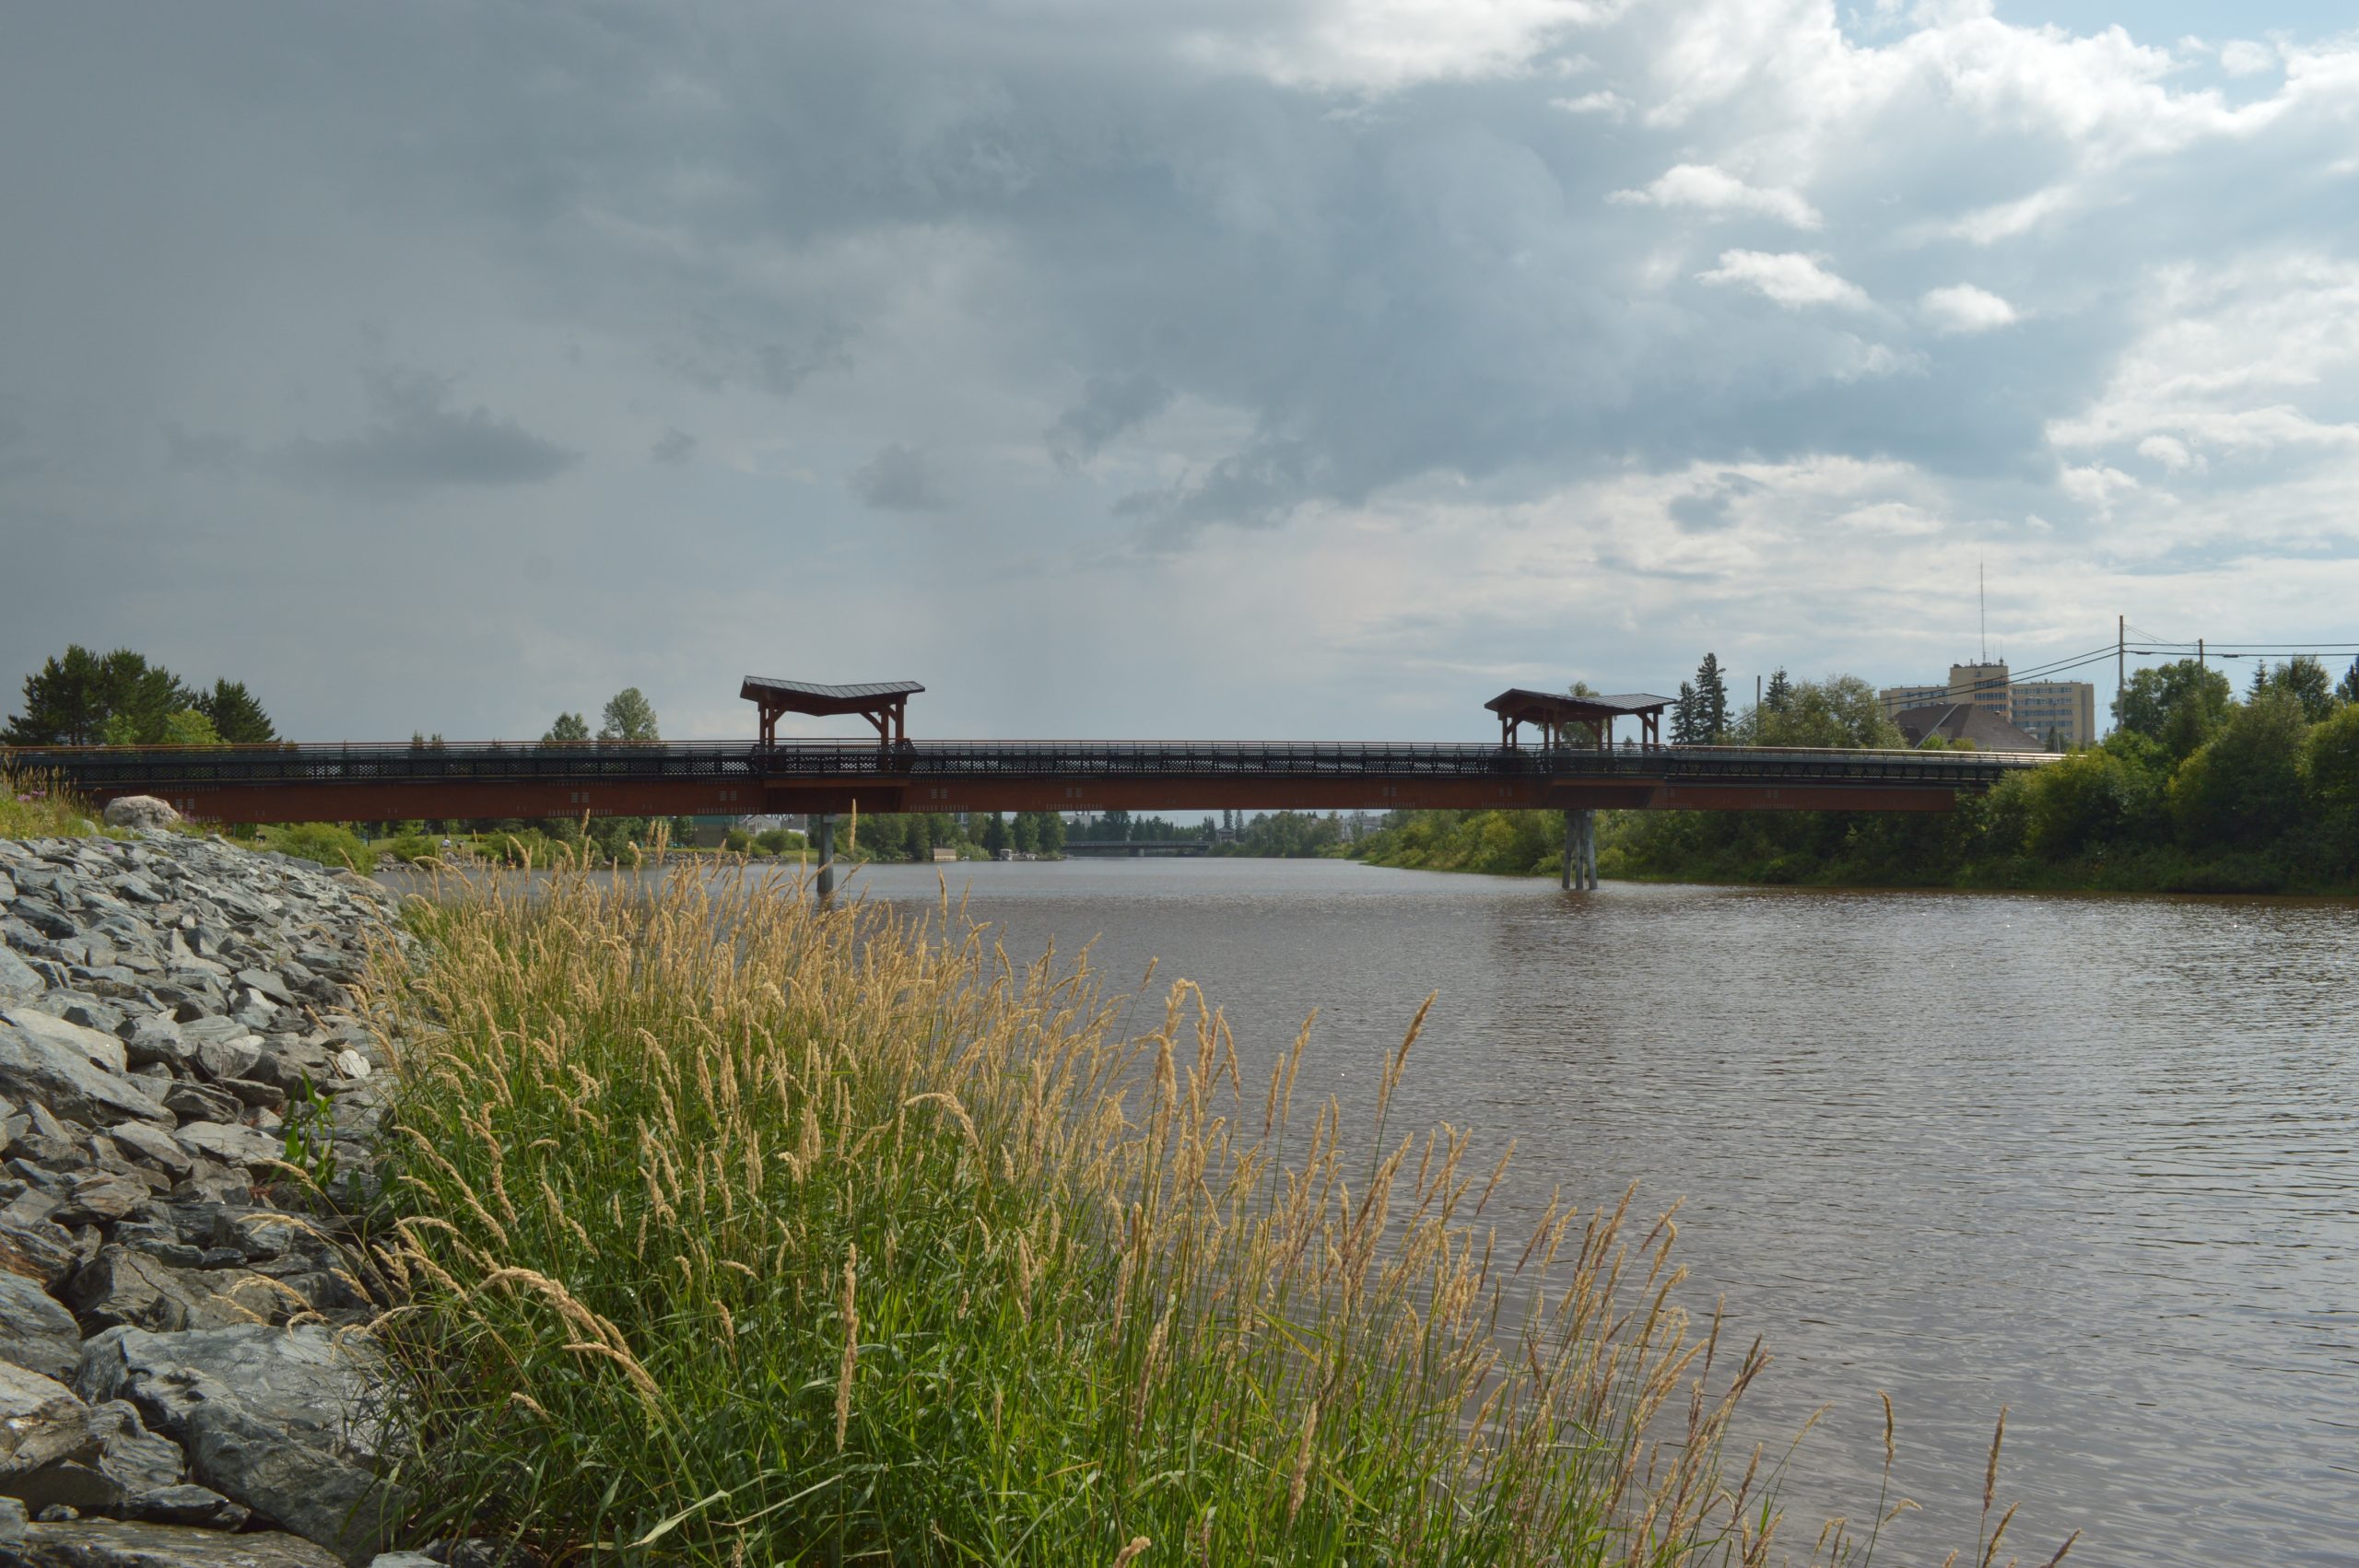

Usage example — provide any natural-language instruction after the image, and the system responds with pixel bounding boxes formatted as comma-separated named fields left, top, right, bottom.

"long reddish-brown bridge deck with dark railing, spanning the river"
left=12, top=741, right=2052, bottom=823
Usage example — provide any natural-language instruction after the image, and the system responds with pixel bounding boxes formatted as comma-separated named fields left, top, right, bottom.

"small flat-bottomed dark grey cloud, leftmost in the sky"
left=281, top=370, right=581, bottom=490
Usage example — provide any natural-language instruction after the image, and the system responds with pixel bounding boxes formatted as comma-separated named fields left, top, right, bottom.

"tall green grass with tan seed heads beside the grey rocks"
left=354, top=872, right=2066, bottom=1568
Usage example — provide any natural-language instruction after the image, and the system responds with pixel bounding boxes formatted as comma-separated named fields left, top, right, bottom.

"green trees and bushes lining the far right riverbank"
left=1354, top=661, right=2359, bottom=894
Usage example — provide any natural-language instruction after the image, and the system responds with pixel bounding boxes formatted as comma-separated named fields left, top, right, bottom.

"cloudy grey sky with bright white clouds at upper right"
left=0, top=0, right=2359, bottom=738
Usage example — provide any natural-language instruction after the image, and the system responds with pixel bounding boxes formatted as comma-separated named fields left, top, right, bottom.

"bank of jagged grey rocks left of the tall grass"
left=0, top=802, right=439, bottom=1568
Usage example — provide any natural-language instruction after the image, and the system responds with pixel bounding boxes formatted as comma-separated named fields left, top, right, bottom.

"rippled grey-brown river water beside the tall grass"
left=816, top=860, right=2359, bottom=1568
